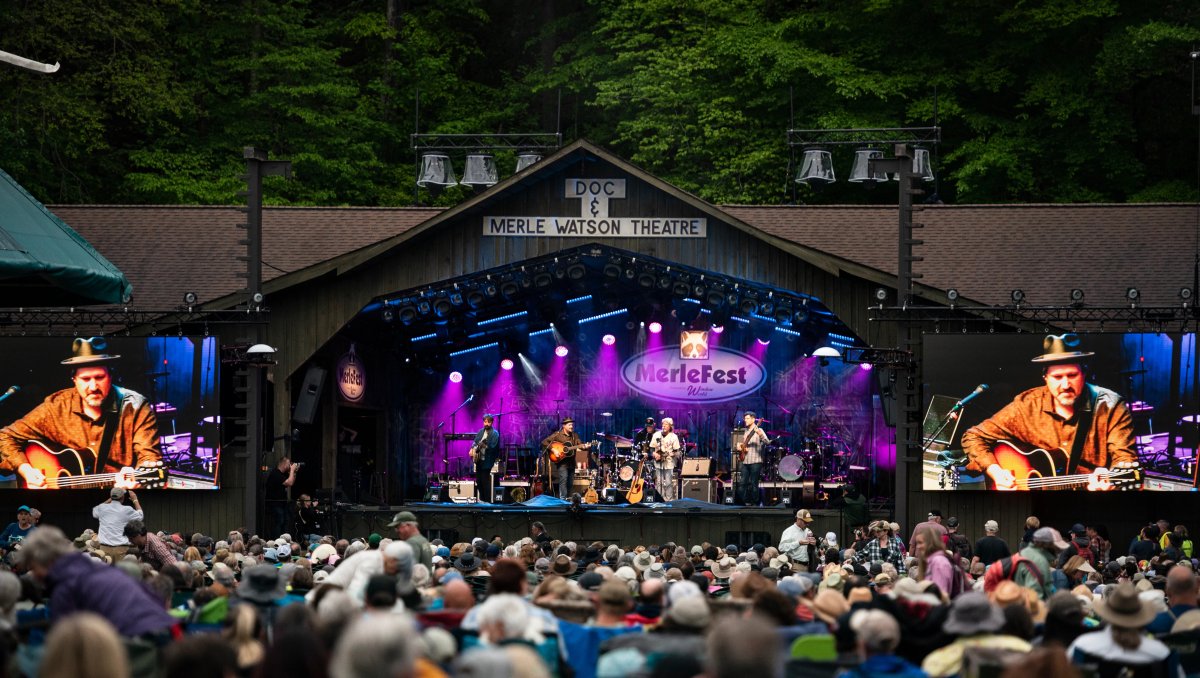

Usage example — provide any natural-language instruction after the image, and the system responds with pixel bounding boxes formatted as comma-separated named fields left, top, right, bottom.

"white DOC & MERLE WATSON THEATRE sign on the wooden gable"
left=484, top=179, right=708, bottom=238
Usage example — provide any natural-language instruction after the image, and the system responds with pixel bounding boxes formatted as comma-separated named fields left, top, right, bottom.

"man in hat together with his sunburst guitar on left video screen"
left=0, top=337, right=162, bottom=488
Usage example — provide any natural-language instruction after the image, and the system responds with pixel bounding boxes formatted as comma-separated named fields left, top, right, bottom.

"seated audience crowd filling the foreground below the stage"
left=0, top=490, right=1200, bottom=678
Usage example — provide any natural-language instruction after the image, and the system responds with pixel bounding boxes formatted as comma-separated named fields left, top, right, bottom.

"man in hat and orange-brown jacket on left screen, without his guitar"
left=0, top=337, right=162, bottom=488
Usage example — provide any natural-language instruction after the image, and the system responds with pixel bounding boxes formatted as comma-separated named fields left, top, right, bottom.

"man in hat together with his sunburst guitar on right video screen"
left=962, top=332, right=1140, bottom=491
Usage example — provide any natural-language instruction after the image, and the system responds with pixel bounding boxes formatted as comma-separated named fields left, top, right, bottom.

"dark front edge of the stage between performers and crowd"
left=341, top=496, right=886, bottom=547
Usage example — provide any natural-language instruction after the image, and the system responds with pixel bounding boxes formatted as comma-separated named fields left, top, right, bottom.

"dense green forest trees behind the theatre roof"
left=0, top=0, right=1200, bottom=205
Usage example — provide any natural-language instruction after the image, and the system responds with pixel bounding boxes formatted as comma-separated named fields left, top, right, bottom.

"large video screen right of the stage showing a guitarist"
left=922, top=332, right=1200, bottom=492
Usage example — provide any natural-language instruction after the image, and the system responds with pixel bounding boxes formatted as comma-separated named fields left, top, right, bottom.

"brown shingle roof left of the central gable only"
left=50, top=205, right=442, bottom=308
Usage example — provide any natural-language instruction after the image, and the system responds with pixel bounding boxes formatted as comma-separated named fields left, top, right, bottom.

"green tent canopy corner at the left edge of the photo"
left=0, top=170, right=133, bottom=307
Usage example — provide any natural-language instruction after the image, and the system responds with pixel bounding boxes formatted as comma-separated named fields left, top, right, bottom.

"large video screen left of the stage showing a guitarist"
left=0, top=336, right=221, bottom=490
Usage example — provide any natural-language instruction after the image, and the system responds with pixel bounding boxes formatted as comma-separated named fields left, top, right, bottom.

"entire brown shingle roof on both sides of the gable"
left=52, top=199, right=1200, bottom=308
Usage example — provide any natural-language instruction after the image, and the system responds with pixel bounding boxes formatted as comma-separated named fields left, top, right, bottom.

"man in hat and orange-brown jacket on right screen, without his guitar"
left=962, top=332, right=1138, bottom=491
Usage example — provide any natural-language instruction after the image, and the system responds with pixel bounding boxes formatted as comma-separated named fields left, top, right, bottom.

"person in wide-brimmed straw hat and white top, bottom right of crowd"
left=1067, top=582, right=1183, bottom=678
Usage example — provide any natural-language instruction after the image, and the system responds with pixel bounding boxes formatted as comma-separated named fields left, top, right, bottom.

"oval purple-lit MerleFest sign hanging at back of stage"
left=620, top=346, right=767, bottom=404
